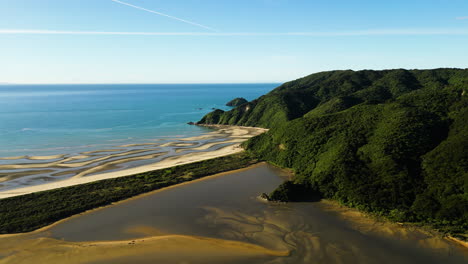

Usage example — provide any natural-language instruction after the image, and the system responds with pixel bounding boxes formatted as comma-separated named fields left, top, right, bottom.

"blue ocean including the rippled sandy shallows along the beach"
left=0, top=84, right=278, bottom=191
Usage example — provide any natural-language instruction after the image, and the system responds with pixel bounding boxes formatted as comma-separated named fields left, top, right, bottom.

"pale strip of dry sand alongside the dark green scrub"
left=0, top=126, right=267, bottom=199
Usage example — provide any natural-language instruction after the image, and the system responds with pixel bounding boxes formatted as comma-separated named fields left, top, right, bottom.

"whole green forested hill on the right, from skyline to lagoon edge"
left=199, top=69, right=468, bottom=233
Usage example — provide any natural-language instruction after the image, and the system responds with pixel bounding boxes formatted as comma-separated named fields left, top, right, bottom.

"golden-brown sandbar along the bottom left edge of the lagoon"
left=0, top=235, right=289, bottom=264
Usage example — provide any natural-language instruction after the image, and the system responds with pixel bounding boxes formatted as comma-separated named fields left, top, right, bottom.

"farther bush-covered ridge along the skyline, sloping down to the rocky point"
left=198, top=69, right=468, bottom=128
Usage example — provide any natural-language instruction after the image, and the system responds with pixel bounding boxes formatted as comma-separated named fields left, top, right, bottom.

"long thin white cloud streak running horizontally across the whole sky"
left=0, top=29, right=468, bottom=37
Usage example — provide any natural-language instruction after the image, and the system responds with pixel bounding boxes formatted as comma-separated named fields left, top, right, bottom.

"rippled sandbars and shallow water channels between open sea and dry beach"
left=0, top=127, right=264, bottom=193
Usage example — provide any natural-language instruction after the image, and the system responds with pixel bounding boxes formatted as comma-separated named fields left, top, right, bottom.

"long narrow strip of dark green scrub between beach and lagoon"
left=0, top=153, right=257, bottom=234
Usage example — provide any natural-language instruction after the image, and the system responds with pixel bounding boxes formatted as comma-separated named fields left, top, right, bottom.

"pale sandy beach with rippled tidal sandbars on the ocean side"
left=0, top=126, right=267, bottom=199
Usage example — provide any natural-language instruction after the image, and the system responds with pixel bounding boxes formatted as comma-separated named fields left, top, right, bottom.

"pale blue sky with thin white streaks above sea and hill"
left=0, top=0, right=468, bottom=83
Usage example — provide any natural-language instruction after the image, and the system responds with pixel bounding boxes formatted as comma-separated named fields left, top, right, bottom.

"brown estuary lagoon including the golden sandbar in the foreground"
left=0, top=164, right=467, bottom=264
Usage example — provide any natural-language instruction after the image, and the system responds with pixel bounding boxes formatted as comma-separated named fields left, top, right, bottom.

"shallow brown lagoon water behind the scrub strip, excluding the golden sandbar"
left=0, top=164, right=468, bottom=264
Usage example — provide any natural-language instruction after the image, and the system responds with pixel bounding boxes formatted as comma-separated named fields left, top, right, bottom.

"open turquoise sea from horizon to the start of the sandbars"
left=0, top=84, right=278, bottom=157
